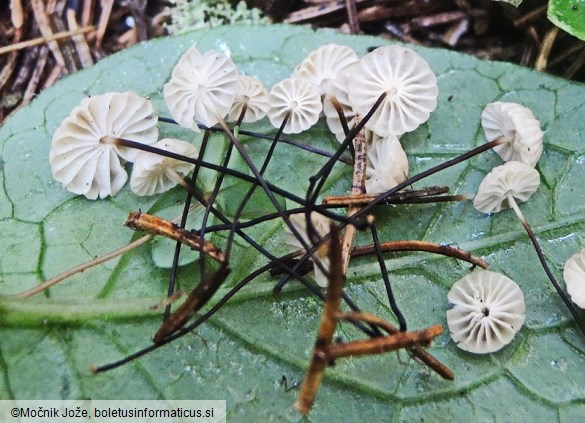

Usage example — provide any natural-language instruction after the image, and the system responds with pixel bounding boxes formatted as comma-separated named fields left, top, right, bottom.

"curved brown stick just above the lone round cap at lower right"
left=352, top=240, right=488, bottom=269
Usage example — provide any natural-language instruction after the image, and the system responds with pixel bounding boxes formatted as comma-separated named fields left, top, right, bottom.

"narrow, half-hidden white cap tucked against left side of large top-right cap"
left=323, top=63, right=356, bottom=142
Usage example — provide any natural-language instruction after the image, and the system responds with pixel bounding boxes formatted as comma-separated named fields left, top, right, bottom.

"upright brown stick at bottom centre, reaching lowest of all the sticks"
left=295, top=224, right=345, bottom=415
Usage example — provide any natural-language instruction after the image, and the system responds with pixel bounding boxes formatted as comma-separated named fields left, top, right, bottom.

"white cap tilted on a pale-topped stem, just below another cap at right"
left=473, top=162, right=540, bottom=213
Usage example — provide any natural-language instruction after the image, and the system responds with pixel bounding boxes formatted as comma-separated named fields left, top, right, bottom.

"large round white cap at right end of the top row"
left=349, top=45, right=439, bottom=136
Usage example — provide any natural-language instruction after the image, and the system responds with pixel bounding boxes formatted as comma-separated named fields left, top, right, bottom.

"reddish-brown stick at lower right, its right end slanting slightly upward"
left=325, top=325, right=443, bottom=361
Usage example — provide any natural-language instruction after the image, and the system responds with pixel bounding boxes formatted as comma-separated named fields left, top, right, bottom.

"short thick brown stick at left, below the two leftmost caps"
left=125, top=212, right=225, bottom=263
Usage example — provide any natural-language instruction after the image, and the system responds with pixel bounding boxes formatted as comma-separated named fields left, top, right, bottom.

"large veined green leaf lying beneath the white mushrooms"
left=0, top=26, right=585, bottom=422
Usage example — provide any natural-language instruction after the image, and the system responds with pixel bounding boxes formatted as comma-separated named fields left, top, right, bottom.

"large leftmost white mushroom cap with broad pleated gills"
left=49, top=92, right=158, bottom=200
